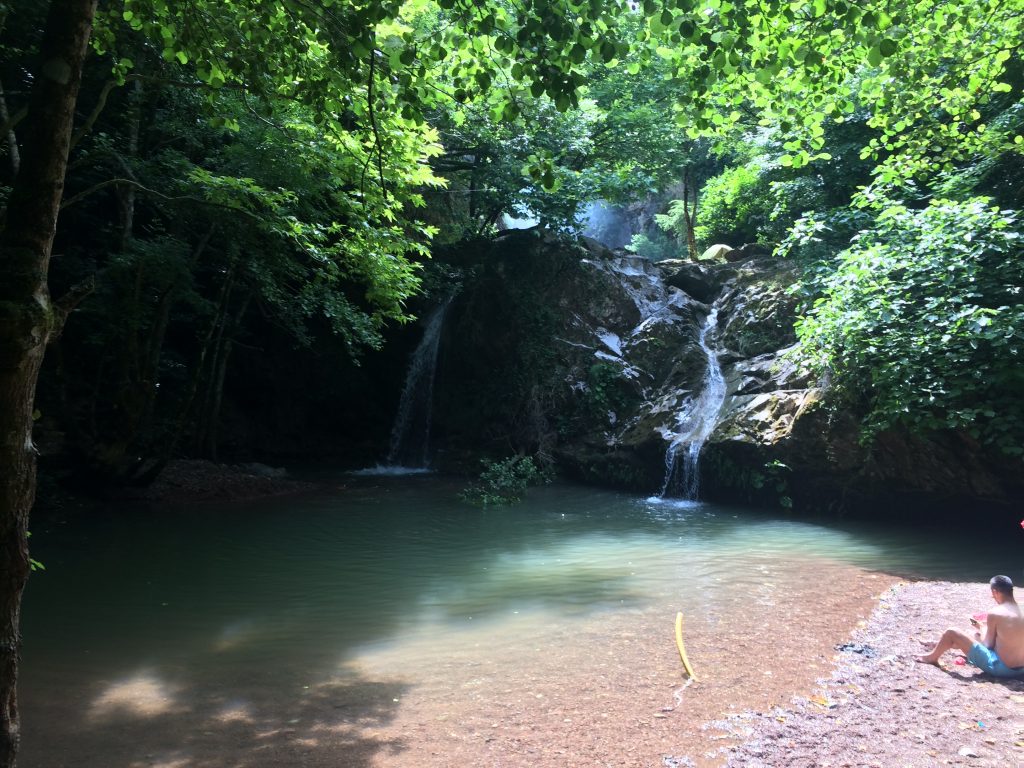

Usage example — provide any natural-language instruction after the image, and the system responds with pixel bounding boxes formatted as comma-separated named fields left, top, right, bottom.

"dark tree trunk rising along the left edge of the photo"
left=0, top=0, right=96, bottom=768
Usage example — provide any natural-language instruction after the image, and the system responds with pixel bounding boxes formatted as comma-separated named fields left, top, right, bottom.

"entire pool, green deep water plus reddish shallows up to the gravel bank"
left=19, top=476, right=1019, bottom=768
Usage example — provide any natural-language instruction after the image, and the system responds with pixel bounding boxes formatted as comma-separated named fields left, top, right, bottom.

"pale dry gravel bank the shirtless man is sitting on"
left=716, top=583, right=1024, bottom=768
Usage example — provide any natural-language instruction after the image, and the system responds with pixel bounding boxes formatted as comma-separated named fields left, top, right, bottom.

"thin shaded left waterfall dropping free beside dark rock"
left=387, top=296, right=452, bottom=469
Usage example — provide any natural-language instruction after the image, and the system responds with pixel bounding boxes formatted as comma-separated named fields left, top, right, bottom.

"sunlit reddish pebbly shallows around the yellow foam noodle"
left=333, top=563, right=892, bottom=768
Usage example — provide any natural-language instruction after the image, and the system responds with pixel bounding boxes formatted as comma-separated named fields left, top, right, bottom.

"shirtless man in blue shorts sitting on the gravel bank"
left=915, top=575, right=1024, bottom=677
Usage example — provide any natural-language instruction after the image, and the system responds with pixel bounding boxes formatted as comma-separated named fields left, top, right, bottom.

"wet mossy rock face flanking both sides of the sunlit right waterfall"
left=435, top=230, right=847, bottom=492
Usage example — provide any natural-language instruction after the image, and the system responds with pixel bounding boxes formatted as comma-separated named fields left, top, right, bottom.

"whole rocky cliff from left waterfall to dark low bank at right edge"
left=434, top=229, right=1021, bottom=518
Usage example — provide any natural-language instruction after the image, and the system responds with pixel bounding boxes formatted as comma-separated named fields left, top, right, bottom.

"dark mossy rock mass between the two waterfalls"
left=435, top=230, right=708, bottom=487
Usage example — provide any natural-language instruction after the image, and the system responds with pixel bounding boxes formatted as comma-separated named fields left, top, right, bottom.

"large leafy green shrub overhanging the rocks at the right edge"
left=797, top=198, right=1024, bottom=456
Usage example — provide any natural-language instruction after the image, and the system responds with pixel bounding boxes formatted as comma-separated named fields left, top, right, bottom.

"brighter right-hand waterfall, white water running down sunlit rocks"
left=660, top=303, right=725, bottom=501
